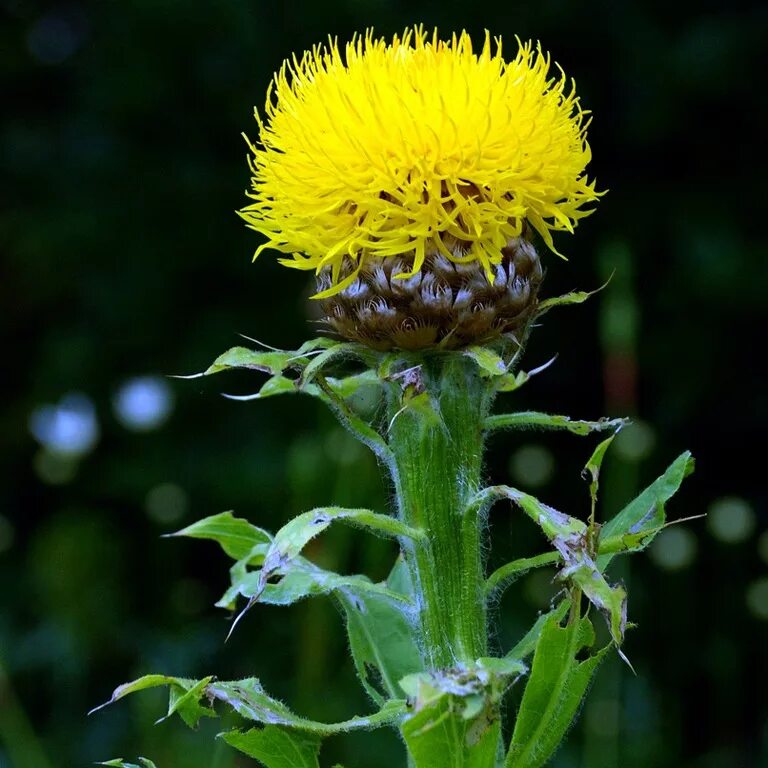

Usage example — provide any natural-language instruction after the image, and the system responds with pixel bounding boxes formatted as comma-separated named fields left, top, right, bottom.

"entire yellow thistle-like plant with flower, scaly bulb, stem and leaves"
left=96, top=27, right=694, bottom=768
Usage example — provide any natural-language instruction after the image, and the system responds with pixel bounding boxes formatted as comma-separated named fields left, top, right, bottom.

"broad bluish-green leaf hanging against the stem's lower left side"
left=336, top=584, right=421, bottom=705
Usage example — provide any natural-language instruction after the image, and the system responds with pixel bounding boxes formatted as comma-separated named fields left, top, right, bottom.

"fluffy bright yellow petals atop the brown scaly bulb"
left=241, top=27, right=600, bottom=297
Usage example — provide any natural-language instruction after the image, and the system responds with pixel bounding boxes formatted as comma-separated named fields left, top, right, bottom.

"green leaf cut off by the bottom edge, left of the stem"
left=220, top=725, right=320, bottom=768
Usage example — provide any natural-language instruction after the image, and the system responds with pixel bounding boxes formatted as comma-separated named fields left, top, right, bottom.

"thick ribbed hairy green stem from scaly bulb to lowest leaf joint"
left=388, top=354, right=492, bottom=670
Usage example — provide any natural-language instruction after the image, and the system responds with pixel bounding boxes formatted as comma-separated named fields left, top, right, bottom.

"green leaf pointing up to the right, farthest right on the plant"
left=597, top=451, right=694, bottom=571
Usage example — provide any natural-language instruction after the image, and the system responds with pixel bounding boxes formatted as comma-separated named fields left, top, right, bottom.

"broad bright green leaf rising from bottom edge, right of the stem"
left=504, top=614, right=607, bottom=768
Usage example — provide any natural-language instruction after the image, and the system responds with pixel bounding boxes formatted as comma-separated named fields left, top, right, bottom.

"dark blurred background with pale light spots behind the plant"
left=0, top=0, right=768, bottom=768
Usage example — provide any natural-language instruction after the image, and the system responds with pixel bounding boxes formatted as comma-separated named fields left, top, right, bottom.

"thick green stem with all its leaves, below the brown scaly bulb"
left=96, top=286, right=693, bottom=768
